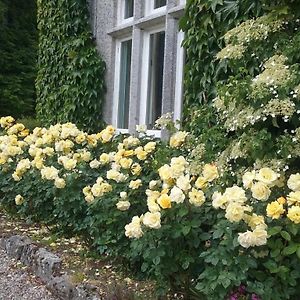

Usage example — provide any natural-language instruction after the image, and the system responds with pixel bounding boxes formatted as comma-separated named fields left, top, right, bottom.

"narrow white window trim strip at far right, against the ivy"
left=173, top=31, right=185, bottom=122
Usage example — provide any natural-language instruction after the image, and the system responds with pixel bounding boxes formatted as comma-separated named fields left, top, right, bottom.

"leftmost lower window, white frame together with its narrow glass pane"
left=113, top=38, right=132, bottom=131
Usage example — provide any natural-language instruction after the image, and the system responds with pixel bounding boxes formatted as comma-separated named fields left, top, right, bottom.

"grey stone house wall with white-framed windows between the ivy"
left=90, top=0, right=185, bottom=136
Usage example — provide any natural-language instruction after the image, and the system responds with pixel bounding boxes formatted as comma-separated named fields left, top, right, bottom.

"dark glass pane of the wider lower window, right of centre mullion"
left=146, top=31, right=165, bottom=128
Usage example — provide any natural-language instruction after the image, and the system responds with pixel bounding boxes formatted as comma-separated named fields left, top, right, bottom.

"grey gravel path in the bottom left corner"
left=0, top=249, right=58, bottom=300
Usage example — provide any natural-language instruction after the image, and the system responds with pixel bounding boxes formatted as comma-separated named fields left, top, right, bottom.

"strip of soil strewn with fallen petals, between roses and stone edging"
left=0, top=208, right=171, bottom=300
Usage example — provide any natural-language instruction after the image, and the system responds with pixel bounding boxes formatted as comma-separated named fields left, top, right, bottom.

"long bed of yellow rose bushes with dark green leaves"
left=0, top=117, right=300, bottom=299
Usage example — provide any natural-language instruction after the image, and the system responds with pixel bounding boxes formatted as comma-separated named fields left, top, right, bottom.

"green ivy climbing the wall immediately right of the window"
left=180, top=0, right=262, bottom=139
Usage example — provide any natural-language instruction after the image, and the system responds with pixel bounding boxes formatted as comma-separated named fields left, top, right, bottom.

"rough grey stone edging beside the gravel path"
left=0, top=235, right=101, bottom=300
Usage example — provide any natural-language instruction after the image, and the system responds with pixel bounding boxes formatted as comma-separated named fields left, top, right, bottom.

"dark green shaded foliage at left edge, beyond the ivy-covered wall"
left=0, top=0, right=37, bottom=118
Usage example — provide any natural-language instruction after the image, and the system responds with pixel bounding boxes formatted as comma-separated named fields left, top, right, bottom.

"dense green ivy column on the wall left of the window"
left=36, top=0, right=105, bottom=131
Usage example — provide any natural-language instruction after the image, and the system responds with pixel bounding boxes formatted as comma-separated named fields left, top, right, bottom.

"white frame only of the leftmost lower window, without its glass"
left=112, top=36, right=132, bottom=133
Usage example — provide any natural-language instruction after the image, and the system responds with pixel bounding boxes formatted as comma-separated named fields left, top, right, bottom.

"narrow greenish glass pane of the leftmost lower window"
left=117, top=40, right=132, bottom=128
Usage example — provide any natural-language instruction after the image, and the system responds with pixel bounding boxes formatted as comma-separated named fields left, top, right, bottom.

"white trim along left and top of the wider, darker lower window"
left=139, top=25, right=166, bottom=137
